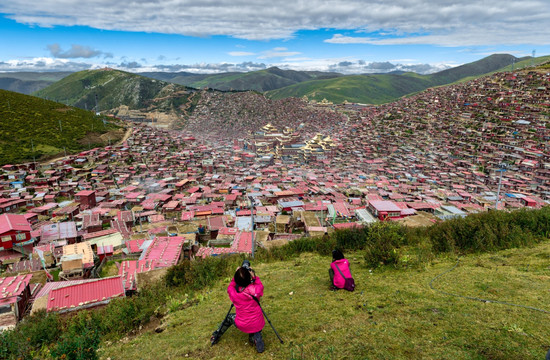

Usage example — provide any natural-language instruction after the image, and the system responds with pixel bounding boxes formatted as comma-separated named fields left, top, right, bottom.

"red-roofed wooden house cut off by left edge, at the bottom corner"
left=0, top=274, right=32, bottom=331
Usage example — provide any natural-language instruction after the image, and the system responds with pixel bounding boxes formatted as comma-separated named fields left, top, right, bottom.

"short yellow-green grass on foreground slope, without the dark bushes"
left=99, top=242, right=550, bottom=360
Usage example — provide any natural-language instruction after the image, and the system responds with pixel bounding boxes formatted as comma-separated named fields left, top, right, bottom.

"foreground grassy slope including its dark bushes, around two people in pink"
left=0, top=207, right=550, bottom=359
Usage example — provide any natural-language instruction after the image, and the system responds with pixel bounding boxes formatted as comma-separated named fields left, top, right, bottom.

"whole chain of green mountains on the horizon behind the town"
left=30, top=54, right=550, bottom=112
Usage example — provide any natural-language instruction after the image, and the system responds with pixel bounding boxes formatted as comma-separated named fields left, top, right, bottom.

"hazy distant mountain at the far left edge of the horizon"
left=0, top=72, right=71, bottom=95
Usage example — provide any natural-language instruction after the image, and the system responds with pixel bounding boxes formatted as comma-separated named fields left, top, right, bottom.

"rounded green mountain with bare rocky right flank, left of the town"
left=34, top=69, right=198, bottom=112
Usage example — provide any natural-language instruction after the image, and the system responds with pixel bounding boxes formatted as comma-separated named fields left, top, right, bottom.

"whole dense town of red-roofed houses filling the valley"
left=0, top=67, right=550, bottom=328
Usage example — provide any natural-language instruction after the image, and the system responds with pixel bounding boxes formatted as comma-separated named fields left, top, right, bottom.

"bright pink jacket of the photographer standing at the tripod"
left=227, top=276, right=265, bottom=334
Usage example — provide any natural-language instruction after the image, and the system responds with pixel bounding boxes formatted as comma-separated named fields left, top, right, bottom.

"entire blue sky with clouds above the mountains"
left=0, top=0, right=550, bottom=73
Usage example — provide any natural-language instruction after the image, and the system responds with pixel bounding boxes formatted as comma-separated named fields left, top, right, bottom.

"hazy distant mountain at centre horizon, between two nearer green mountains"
left=141, top=67, right=342, bottom=92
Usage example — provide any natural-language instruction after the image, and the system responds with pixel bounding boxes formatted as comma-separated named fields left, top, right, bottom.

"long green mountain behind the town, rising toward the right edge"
left=266, top=54, right=550, bottom=104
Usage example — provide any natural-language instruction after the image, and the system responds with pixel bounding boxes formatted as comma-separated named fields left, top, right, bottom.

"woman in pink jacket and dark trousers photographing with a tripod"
left=212, top=267, right=265, bottom=353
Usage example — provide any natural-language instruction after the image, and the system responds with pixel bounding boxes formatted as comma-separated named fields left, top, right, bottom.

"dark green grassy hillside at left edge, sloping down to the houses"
left=0, top=90, right=121, bottom=165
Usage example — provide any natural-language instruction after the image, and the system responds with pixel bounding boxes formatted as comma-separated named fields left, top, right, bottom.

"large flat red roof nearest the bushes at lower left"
left=47, top=276, right=125, bottom=312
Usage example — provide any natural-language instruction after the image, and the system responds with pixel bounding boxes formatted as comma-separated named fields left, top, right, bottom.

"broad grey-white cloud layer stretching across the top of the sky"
left=0, top=0, right=550, bottom=45
